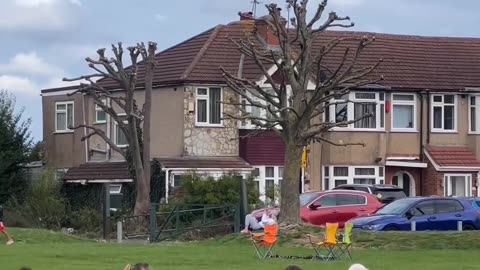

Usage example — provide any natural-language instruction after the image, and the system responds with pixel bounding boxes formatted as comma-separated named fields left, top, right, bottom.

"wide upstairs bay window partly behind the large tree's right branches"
left=327, top=92, right=385, bottom=130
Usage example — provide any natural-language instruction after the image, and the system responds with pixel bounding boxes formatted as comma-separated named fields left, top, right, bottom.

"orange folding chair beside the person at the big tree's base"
left=251, top=224, right=278, bottom=259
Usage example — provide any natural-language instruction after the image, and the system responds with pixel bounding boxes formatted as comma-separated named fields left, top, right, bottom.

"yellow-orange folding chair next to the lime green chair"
left=308, top=223, right=338, bottom=261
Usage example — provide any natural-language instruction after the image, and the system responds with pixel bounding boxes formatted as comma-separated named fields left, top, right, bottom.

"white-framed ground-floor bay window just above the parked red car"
left=322, top=166, right=384, bottom=190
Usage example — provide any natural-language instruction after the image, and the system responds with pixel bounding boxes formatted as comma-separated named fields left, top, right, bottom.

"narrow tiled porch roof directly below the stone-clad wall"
left=157, top=157, right=252, bottom=169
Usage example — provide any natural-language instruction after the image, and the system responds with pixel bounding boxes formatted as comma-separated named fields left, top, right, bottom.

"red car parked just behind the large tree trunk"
left=252, top=190, right=383, bottom=227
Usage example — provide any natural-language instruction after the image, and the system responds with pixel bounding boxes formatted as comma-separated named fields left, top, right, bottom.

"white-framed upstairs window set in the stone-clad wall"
left=196, top=87, right=223, bottom=126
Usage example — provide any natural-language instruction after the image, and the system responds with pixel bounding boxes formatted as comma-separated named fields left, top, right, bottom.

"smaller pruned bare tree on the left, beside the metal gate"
left=64, top=42, right=157, bottom=215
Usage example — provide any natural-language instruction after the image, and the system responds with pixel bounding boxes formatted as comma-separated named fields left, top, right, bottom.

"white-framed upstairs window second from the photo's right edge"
left=431, top=95, right=457, bottom=132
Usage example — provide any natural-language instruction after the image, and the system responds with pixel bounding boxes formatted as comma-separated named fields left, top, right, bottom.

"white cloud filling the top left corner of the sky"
left=0, top=0, right=81, bottom=31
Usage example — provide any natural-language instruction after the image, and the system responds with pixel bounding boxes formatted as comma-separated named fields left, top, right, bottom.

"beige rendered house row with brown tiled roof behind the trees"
left=42, top=10, right=480, bottom=200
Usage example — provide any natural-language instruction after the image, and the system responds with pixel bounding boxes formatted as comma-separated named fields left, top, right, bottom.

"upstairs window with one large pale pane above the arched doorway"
left=392, top=94, right=417, bottom=131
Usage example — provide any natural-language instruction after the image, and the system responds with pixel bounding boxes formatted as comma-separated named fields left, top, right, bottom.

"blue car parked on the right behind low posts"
left=349, top=197, right=480, bottom=231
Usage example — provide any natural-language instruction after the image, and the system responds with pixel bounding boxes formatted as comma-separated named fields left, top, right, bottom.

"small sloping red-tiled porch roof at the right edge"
left=425, top=145, right=480, bottom=168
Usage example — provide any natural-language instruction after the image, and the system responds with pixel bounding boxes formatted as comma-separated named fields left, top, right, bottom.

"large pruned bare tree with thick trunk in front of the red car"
left=221, top=0, right=382, bottom=224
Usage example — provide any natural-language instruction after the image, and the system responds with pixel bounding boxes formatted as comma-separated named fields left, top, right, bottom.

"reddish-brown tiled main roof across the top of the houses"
left=44, top=20, right=480, bottom=91
